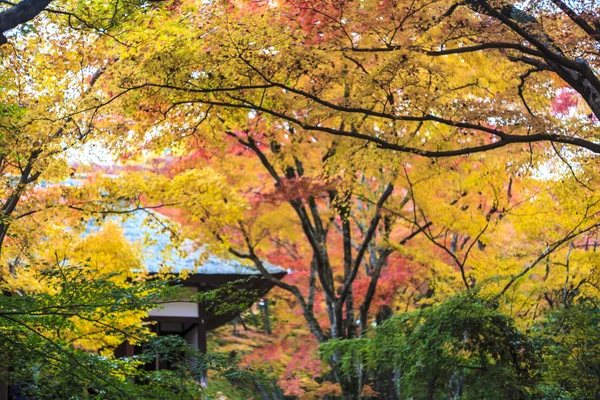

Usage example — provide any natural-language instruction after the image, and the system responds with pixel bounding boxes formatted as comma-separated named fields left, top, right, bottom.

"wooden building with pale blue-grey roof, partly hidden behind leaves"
left=111, top=213, right=286, bottom=362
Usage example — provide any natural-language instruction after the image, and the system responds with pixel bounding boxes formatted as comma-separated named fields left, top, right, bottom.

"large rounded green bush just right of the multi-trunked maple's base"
left=324, top=294, right=540, bottom=399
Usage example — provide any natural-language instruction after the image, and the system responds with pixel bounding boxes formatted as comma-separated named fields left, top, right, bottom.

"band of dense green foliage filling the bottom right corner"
left=322, top=293, right=600, bottom=399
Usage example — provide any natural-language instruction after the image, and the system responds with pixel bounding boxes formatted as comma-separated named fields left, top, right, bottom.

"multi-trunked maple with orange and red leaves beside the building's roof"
left=117, top=125, right=432, bottom=396
